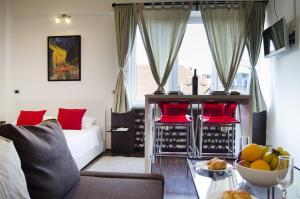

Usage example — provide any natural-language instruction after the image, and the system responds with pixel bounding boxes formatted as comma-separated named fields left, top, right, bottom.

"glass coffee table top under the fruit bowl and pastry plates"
left=187, top=158, right=300, bottom=199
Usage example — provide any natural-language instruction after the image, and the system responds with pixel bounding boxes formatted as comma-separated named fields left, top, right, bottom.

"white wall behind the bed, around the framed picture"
left=4, top=0, right=118, bottom=148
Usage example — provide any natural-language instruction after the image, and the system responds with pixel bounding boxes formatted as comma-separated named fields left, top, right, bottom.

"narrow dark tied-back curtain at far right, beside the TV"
left=246, top=2, right=266, bottom=112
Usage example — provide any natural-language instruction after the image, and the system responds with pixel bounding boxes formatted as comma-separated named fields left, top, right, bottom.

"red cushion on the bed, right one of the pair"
left=57, top=108, right=86, bottom=130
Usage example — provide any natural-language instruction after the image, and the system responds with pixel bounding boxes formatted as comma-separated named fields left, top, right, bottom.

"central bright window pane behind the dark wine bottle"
left=178, top=24, right=214, bottom=94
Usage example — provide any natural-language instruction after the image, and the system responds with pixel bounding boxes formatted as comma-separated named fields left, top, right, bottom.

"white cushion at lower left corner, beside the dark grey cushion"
left=0, top=136, right=30, bottom=199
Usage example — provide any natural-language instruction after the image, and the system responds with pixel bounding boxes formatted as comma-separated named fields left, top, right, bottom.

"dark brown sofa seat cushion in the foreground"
left=64, top=171, right=164, bottom=199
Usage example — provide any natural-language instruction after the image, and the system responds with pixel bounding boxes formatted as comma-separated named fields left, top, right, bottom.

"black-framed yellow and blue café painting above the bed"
left=48, top=35, right=81, bottom=81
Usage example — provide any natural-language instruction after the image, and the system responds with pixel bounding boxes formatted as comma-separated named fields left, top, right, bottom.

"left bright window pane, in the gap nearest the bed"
left=135, top=29, right=157, bottom=100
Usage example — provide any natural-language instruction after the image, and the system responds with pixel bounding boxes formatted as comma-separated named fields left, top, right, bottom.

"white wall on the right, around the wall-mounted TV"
left=265, top=0, right=300, bottom=167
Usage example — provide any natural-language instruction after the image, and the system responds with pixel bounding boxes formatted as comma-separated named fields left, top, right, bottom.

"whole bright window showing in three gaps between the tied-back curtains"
left=129, top=12, right=251, bottom=107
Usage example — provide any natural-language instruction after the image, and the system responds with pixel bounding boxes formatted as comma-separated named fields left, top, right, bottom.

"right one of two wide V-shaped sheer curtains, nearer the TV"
left=200, top=2, right=251, bottom=92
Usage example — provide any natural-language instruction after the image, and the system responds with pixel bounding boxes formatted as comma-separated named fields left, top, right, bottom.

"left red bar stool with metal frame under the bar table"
left=154, top=101, right=192, bottom=173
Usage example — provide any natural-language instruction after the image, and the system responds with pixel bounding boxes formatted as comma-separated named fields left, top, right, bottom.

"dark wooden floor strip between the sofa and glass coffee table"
left=152, top=157, right=198, bottom=199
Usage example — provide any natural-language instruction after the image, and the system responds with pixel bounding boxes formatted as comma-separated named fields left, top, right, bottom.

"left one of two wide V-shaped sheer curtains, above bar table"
left=136, top=4, right=191, bottom=93
